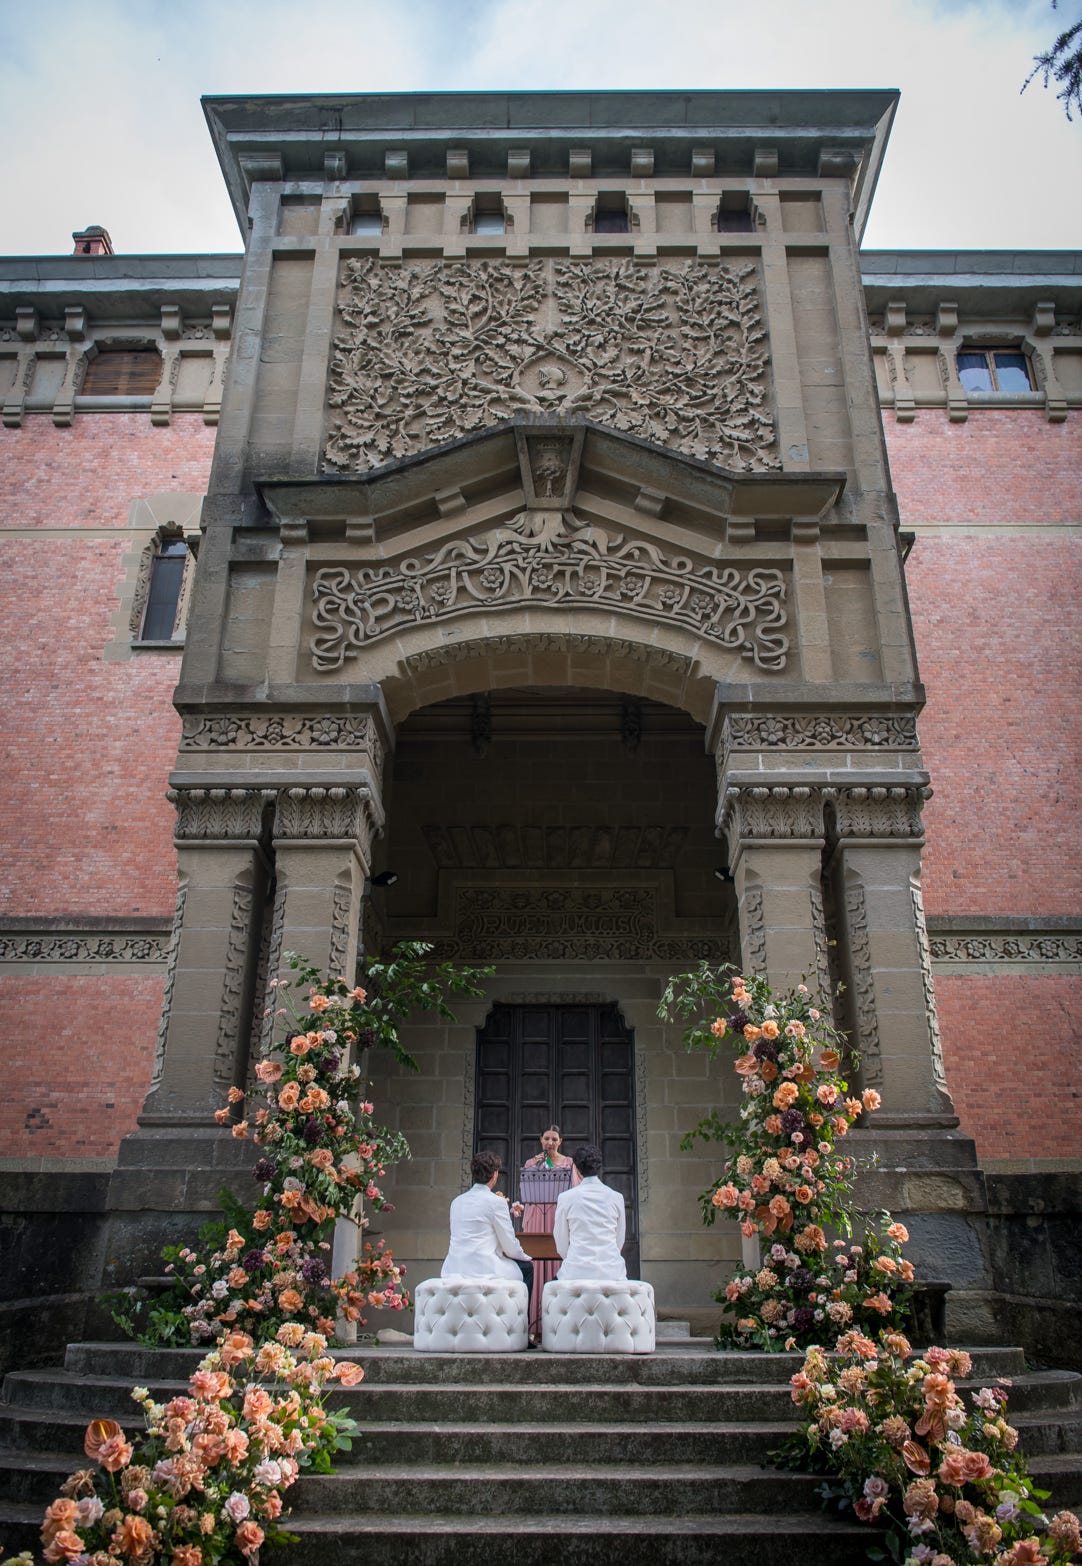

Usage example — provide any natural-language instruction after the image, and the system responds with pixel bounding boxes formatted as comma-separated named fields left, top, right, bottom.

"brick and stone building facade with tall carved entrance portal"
left=0, top=94, right=1082, bottom=1365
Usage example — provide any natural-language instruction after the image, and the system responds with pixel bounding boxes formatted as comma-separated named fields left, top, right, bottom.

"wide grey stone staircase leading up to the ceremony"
left=0, top=1337, right=1082, bottom=1566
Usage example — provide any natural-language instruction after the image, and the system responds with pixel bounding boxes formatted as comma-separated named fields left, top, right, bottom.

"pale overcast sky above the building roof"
left=0, top=0, right=1082, bottom=255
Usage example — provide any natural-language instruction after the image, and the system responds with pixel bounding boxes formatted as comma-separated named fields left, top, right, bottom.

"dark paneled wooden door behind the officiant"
left=474, top=1005, right=639, bottom=1278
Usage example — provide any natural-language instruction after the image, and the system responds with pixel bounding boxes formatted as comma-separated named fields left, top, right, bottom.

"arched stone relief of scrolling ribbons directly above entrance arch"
left=308, top=511, right=789, bottom=672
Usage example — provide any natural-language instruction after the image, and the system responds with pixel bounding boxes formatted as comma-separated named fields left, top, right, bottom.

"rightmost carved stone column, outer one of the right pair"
left=824, top=785, right=957, bottom=1129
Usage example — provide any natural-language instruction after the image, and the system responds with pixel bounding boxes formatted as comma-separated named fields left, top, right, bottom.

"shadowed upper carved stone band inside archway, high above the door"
left=421, top=824, right=687, bottom=869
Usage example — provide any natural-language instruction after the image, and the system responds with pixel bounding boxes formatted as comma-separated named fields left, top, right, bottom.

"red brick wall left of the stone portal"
left=0, top=413, right=215, bottom=1159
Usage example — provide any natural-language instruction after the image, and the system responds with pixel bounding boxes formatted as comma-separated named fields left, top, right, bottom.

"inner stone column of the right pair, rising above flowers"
left=719, top=785, right=830, bottom=993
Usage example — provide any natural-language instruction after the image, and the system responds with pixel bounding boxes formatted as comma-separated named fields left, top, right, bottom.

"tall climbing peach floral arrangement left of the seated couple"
left=113, top=941, right=482, bottom=1345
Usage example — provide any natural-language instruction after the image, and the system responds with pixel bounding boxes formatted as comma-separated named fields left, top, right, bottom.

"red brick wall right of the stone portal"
left=886, top=409, right=1082, bottom=1159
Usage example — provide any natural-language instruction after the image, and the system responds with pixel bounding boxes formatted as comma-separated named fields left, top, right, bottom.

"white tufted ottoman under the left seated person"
left=413, top=1278, right=529, bottom=1355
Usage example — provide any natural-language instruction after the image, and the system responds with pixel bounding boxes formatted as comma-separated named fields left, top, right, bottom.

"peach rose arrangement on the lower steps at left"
left=5, top=1325, right=363, bottom=1566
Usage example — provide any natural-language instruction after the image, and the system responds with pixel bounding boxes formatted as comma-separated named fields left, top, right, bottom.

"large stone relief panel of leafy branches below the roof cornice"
left=324, top=257, right=780, bottom=471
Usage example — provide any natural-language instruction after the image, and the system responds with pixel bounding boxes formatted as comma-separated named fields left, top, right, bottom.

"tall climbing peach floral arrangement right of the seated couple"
left=659, top=963, right=913, bottom=1350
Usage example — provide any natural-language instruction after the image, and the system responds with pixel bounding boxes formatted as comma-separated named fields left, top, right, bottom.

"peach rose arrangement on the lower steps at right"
left=781, top=1331, right=1082, bottom=1566
